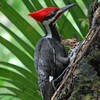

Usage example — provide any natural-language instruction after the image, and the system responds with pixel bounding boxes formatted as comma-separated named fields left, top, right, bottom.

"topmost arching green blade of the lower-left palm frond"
left=0, top=68, right=36, bottom=95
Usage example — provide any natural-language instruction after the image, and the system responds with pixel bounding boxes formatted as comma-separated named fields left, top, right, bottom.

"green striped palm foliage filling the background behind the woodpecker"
left=0, top=0, right=91, bottom=100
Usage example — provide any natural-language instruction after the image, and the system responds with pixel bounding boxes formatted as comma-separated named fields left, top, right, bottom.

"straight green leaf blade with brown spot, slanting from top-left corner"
left=0, top=0, right=41, bottom=45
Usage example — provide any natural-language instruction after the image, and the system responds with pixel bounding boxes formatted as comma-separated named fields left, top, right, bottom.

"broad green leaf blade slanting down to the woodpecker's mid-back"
left=0, top=36, right=35, bottom=73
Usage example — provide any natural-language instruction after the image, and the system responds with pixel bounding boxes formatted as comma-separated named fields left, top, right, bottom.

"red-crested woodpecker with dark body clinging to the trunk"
left=28, top=4, right=75, bottom=100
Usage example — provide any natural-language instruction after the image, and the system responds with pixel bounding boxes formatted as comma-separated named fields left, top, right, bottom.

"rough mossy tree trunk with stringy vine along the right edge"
left=51, top=0, right=100, bottom=100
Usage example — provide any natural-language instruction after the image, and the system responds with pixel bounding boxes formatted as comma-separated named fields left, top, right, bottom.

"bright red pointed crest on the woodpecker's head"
left=28, top=7, right=59, bottom=22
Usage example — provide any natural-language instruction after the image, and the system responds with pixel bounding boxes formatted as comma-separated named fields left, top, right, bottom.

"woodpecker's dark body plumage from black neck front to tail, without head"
left=34, top=22, right=68, bottom=100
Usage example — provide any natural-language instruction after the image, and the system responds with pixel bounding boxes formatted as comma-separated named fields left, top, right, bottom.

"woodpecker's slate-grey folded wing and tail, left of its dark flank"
left=34, top=38, right=54, bottom=100
